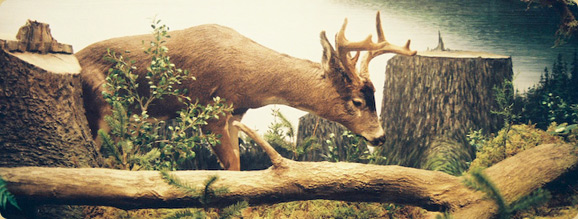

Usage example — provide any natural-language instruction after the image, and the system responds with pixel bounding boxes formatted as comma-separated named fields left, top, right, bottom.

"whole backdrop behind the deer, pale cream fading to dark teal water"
left=0, top=0, right=576, bottom=131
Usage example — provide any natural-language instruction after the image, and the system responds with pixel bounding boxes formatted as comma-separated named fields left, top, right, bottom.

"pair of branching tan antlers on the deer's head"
left=335, top=11, right=417, bottom=79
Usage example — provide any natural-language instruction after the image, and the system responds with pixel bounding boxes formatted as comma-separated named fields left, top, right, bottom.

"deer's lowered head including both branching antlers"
left=320, top=12, right=416, bottom=146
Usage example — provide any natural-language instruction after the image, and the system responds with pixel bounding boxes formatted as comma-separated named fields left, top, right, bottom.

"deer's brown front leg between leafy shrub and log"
left=207, top=111, right=243, bottom=171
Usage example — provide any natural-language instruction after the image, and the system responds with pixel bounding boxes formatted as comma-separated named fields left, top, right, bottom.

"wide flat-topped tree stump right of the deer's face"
left=381, top=51, right=512, bottom=167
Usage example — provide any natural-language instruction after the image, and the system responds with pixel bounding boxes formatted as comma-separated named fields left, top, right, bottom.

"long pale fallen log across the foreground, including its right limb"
left=0, top=144, right=578, bottom=218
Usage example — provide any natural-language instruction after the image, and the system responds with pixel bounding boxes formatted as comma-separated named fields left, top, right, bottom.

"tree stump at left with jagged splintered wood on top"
left=0, top=21, right=98, bottom=218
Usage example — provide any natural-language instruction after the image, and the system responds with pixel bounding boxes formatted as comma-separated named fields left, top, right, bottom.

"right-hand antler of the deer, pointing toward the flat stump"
left=359, top=11, right=417, bottom=79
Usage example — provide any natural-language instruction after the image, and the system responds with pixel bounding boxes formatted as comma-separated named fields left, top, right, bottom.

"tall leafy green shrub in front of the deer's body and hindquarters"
left=98, top=20, right=231, bottom=170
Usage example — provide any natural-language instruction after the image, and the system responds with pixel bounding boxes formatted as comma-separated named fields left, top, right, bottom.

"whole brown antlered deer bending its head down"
left=76, top=12, right=416, bottom=170
